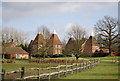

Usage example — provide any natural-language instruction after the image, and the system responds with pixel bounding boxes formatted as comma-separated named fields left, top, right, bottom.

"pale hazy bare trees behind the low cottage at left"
left=1, top=27, right=28, bottom=45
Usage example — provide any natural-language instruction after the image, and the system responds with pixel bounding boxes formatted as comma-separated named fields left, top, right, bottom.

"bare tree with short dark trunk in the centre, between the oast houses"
left=66, top=24, right=85, bottom=60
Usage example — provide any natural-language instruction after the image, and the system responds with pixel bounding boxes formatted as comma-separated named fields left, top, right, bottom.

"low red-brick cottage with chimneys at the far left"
left=2, top=39, right=29, bottom=59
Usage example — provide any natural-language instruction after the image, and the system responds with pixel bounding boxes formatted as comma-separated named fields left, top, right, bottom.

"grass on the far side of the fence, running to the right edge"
left=2, top=56, right=120, bottom=72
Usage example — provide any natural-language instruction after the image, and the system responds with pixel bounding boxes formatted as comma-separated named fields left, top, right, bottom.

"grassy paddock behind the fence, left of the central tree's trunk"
left=2, top=57, right=79, bottom=72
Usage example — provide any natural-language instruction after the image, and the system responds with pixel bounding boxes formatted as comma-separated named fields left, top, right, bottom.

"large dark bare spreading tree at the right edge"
left=95, top=16, right=118, bottom=54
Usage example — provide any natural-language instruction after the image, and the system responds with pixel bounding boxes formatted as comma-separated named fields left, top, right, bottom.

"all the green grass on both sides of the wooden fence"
left=2, top=57, right=120, bottom=79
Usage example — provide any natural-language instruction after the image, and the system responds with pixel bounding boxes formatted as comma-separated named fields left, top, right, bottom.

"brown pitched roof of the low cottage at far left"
left=4, top=47, right=28, bottom=54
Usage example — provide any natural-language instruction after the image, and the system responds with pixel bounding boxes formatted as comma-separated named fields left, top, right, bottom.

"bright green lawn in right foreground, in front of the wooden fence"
left=61, top=62, right=120, bottom=79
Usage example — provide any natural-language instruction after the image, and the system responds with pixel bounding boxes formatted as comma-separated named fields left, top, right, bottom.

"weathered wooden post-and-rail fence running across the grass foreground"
left=1, top=59, right=100, bottom=81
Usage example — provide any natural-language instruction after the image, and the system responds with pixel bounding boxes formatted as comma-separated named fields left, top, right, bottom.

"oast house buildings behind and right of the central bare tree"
left=66, top=36, right=109, bottom=57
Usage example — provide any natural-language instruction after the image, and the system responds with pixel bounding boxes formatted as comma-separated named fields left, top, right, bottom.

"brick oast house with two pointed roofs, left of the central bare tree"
left=29, top=32, right=62, bottom=56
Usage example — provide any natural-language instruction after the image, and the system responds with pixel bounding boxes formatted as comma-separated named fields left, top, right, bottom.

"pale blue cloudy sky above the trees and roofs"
left=0, top=2, right=118, bottom=41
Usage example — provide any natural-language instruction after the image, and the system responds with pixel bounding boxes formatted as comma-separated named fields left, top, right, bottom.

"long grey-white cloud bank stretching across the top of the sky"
left=2, top=2, right=115, bottom=21
